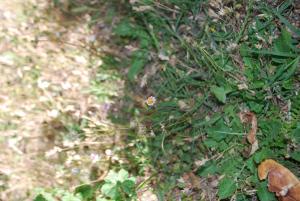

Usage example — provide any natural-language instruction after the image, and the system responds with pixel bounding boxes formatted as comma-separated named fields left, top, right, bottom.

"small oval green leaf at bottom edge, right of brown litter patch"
left=218, top=177, right=236, bottom=199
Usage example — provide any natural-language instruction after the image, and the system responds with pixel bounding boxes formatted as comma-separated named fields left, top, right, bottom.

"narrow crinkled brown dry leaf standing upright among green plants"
left=239, top=111, right=258, bottom=156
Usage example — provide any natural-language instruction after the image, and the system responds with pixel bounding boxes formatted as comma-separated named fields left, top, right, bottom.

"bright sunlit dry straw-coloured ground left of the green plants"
left=0, top=0, right=113, bottom=201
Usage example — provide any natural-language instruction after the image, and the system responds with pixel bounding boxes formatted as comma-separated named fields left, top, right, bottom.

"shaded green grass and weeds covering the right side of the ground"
left=35, top=0, right=300, bottom=201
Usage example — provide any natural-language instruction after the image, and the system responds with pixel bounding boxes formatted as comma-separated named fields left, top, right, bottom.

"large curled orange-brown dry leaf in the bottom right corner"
left=258, top=159, right=300, bottom=201
